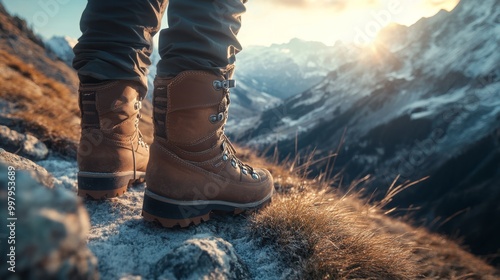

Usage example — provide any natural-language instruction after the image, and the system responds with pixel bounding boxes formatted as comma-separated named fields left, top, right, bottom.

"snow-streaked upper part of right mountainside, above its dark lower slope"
left=247, top=0, right=500, bottom=163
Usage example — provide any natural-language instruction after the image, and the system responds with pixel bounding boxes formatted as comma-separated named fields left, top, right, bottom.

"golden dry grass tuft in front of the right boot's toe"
left=252, top=187, right=417, bottom=279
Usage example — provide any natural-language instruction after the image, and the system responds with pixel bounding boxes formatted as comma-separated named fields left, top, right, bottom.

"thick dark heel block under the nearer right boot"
left=142, top=190, right=212, bottom=228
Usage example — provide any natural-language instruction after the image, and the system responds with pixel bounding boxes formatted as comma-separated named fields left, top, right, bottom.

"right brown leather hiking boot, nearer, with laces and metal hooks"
left=142, top=71, right=274, bottom=227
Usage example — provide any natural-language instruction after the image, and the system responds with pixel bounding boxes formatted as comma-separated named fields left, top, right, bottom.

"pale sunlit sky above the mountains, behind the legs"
left=0, top=0, right=459, bottom=46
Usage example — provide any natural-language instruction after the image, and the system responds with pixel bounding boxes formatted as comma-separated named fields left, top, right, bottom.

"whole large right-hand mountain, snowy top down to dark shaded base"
left=238, top=0, right=500, bottom=262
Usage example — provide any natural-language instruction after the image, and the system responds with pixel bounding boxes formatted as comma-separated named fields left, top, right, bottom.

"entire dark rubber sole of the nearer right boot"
left=142, top=189, right=273, bottom=228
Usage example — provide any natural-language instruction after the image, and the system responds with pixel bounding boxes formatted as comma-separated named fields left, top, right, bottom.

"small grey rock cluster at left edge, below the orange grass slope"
left=0, top=125, right=49, bottom=160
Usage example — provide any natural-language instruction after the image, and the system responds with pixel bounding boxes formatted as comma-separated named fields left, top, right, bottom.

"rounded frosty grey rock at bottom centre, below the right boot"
left=155, top=234, right=250, bottom=279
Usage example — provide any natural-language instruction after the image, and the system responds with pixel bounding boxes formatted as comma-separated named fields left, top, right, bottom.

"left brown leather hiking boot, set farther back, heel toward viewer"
left=77, top=80, right=149, bottom=199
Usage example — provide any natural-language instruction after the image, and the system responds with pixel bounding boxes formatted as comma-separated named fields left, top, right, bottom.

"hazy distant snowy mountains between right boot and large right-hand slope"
left=227, top=39, right=359, bottom=135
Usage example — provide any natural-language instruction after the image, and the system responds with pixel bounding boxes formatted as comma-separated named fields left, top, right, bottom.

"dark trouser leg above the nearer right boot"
left=158, top=0, right=245, bottom=77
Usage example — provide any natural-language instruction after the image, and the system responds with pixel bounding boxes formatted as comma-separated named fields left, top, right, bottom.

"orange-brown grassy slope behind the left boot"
left=0, top=3, right=153, bottom=153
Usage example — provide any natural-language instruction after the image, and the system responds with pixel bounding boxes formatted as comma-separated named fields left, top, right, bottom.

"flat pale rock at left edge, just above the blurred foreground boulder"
left=0, top=148, right=54, bottom=188
